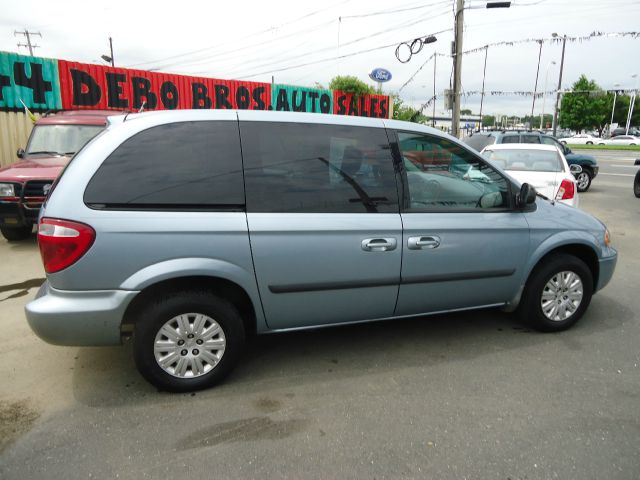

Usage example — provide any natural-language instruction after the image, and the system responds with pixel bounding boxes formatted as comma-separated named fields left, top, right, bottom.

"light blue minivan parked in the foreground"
left=26, top=110, right=617, bottom=391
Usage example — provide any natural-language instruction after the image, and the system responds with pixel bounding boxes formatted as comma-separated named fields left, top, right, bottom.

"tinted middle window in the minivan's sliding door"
left=240, top=122, right=399, bottom=213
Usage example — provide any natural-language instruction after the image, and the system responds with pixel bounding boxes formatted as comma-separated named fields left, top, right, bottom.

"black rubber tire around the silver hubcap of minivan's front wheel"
left=518, top=253, right=593, bottom=332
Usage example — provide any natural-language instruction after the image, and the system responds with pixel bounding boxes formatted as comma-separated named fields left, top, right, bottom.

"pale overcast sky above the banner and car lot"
left=0, top=0, right=640, bottom=115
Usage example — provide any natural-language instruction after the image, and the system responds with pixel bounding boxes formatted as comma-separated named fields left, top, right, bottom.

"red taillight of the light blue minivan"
left=38, top=218, right=96, bottom=273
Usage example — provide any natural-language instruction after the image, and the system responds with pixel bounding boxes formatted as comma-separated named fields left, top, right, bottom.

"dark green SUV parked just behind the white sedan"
left=463, top=130, right=600, bottom=192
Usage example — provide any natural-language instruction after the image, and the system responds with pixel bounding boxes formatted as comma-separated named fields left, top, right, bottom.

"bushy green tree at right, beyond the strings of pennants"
left=558, top=75, right=611, bottom=132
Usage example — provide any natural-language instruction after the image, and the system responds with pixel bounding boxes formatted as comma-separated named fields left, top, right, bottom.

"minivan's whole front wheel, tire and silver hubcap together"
left=518, top=254, right=593, bottom=332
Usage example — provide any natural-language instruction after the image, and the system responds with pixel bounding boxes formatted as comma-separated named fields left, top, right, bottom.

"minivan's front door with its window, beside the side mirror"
left=395, top=132, right=529, bottom=315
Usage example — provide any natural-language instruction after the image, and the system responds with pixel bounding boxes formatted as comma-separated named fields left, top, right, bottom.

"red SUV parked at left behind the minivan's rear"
left=0, top=110, right=114, bottom=241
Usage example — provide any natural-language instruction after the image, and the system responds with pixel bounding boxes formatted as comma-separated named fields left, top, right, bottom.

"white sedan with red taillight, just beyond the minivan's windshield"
left=482, top=143, right=578, bottom=207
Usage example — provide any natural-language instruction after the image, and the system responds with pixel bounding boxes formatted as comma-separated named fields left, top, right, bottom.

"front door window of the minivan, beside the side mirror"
left=398, top=132, right=510, bottom=212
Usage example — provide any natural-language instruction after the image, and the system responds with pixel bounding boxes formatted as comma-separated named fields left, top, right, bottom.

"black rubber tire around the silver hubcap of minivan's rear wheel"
left=133, top=291, right=245, bottom=392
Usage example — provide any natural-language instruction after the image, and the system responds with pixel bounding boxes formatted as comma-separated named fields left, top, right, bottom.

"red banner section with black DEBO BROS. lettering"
left=58, top=60, right=272, bottom=110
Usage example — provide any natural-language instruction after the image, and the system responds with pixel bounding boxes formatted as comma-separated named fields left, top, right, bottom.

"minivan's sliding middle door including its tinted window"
left=239, top=117, right=402, bottom=329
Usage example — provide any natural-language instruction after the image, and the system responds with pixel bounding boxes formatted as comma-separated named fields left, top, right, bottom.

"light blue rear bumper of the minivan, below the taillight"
left=25, top=282, right=138, bottom=346
